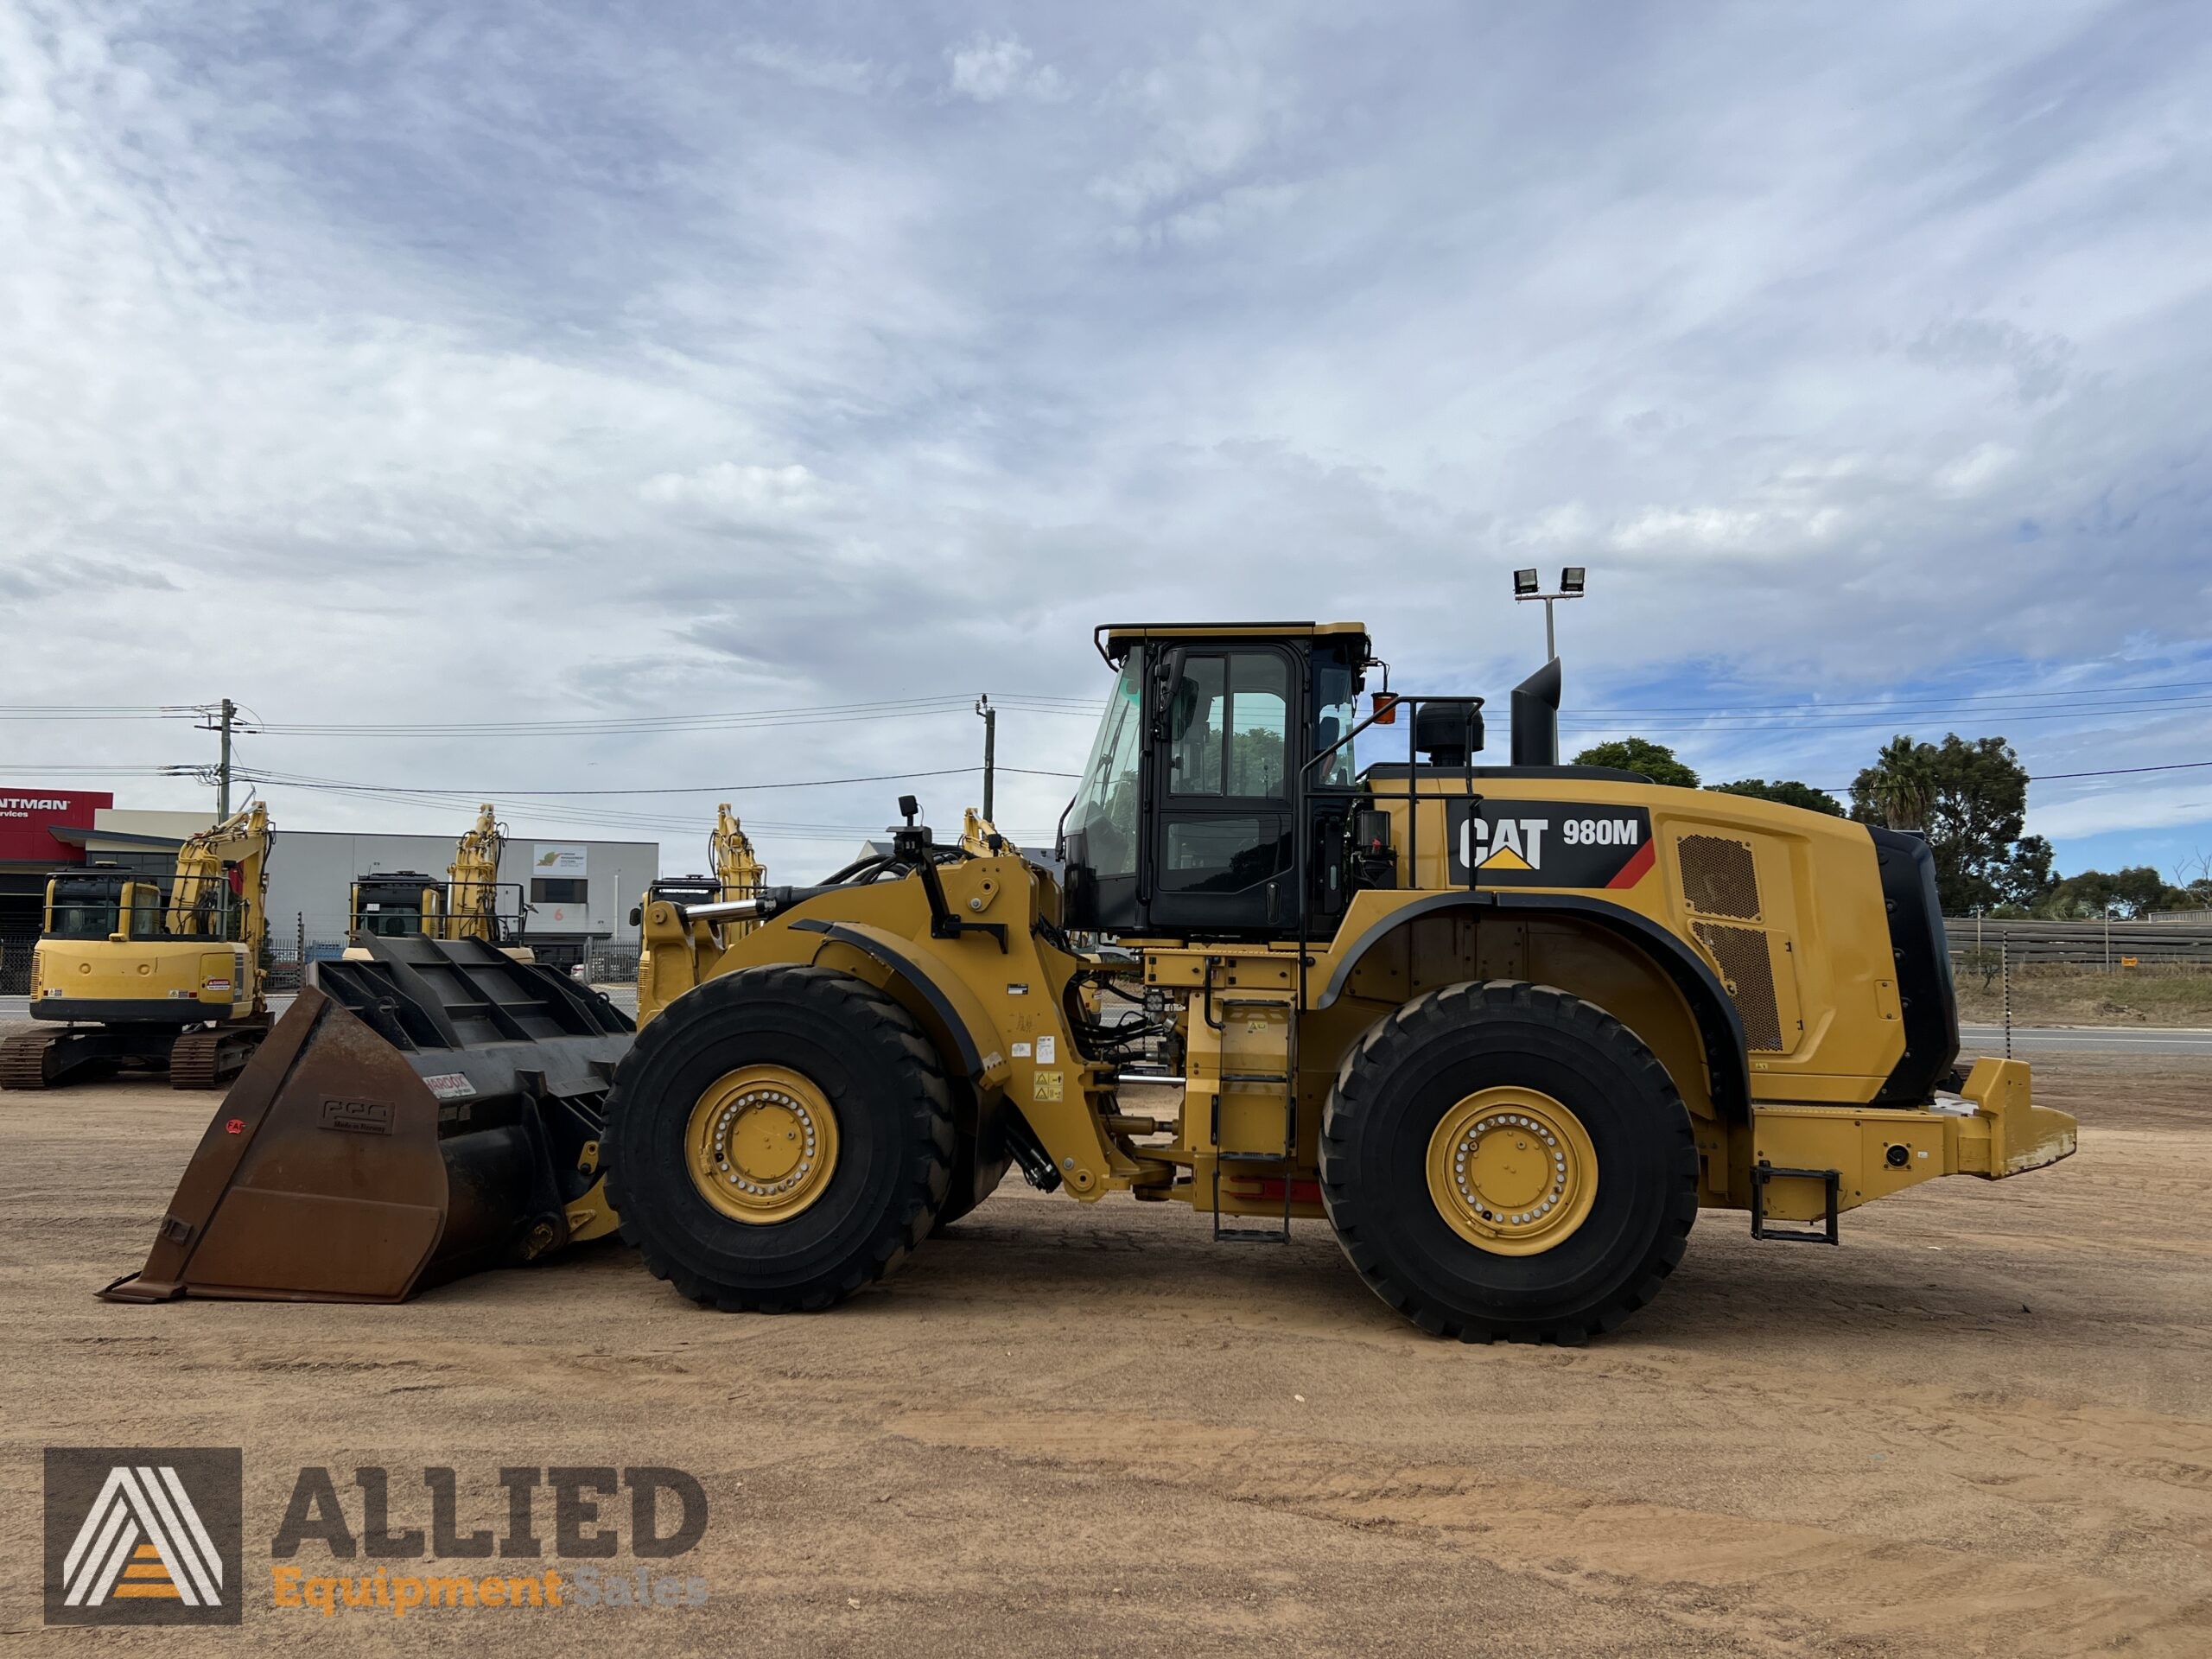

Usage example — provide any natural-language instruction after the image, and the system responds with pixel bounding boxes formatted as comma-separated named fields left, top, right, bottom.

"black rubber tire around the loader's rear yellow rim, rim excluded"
left=1320, top=980, right=1697, bottom=1343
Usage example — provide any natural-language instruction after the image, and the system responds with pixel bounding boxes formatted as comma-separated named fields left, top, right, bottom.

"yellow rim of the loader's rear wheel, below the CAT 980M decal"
left=1429, top=1089, right=1597, bottom=1256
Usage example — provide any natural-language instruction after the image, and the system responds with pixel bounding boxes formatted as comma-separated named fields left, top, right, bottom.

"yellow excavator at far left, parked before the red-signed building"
left=0, top=801, right=274, bottom=1089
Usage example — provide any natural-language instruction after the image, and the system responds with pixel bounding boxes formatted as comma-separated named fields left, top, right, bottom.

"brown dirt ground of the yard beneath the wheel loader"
left=0, top=1058, right=2212, bottom=1656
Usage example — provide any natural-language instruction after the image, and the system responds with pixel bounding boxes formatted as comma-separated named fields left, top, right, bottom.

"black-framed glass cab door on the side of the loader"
left=1146, top=646, right=1300, bottom=933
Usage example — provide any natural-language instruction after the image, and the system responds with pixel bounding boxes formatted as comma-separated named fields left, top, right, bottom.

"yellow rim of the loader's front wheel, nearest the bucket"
left=683, top=1066, right=836, bottom=1225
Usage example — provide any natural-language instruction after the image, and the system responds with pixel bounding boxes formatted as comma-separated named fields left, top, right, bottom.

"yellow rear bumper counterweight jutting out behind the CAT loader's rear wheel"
left=1752, top=1059, right=2075, bottom=1221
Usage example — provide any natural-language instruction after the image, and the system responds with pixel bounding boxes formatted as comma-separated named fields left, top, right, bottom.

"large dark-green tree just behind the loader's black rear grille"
left=1852, top=732, right=2057, bottom=916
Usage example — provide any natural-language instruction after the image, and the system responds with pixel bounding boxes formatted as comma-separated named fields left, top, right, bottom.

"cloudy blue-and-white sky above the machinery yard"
left=0, top=0, right=2212, bottom=880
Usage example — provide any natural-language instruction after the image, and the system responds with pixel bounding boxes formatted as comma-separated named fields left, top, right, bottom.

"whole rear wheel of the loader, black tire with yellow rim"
left=1320, top=980, right=1697, bottom=1343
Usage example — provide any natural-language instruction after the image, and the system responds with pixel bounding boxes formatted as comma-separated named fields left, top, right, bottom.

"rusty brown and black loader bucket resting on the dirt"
left=99, top=938, right=635, bottom=1303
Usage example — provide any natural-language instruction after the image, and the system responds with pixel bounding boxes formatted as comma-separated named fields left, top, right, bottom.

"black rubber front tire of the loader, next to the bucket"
left=606, top=964, right=953, bottom=1314
